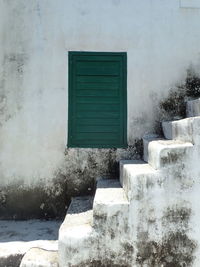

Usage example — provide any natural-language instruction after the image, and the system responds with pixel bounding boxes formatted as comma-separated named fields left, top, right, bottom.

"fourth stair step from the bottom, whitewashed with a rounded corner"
left=144, top=138, right=193, bottom=169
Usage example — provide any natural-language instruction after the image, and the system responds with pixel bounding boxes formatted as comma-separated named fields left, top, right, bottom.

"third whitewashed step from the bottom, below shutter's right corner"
left=120, top=160, right=159, bottom=201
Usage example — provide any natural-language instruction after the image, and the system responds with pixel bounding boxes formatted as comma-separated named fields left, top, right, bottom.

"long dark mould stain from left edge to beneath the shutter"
left=0, top=140, right=142, bottom=219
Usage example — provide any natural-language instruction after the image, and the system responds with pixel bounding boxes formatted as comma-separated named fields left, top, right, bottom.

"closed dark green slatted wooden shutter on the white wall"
left=68, top=52, right=127, bottom=148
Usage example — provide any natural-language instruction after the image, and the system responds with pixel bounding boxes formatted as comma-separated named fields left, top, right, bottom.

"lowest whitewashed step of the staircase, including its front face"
left=58, top=197, right=97, bottom=267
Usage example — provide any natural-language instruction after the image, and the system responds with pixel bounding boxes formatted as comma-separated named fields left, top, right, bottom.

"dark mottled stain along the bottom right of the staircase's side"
left=136, top=231, right=196, bottom=267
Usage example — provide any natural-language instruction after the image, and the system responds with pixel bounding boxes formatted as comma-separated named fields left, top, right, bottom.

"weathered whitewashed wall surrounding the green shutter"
left=0, top=0, right=200, bottom=217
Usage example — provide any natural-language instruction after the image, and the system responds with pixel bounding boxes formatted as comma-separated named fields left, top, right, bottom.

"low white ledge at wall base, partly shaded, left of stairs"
left=0, top=220, right=61, bottom=267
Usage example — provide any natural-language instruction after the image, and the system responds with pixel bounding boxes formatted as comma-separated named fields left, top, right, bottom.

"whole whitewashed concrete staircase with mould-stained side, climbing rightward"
left=18, top=99, right=200, bottom=267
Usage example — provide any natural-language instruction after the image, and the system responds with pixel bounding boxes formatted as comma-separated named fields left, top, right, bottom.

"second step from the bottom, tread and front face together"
left=93, top=179, right=129, bottom=225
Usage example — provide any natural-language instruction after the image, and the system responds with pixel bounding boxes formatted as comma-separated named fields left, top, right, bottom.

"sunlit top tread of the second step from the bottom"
left=94, top=179, right=128, bottom=205
